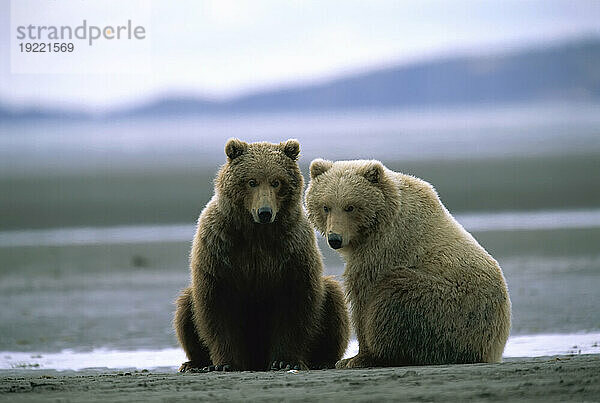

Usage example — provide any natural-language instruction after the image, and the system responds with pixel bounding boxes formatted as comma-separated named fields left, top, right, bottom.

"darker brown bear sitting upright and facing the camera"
left=174, top=139, right=350, bottom=372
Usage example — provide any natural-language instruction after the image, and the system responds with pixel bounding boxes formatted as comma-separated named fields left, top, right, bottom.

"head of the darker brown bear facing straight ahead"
left=215, top=139, right=304, bottom=224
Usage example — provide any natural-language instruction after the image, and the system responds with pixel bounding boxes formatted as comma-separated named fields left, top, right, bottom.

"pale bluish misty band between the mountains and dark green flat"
left=0, top=100, right=600, bottom=178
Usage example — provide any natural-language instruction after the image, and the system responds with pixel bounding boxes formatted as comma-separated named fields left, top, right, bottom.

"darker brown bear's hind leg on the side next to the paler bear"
left=308, top=277, right=350, bottom=369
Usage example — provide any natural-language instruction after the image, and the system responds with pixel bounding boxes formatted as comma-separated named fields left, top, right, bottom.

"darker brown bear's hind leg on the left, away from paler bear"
left=173, top=287, right=211, bottom=372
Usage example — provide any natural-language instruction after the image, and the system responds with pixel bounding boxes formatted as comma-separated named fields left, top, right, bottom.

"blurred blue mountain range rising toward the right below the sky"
left=0, top=38, right=600, bottom=119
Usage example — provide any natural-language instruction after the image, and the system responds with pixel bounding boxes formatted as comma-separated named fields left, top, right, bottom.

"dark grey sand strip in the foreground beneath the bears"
left=0, top=355, right=600, bottom=402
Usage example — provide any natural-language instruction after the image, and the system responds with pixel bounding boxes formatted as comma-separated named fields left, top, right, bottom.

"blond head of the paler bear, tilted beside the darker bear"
left=306, top=159, right=393, bottom=250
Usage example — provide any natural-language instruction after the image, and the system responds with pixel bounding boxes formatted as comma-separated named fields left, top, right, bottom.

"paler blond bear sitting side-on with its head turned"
left=306, top=159, right=511, bottom=368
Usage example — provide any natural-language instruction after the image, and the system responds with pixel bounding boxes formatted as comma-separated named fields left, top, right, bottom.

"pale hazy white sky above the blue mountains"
left=0, top=0, right=600, bottom=108
